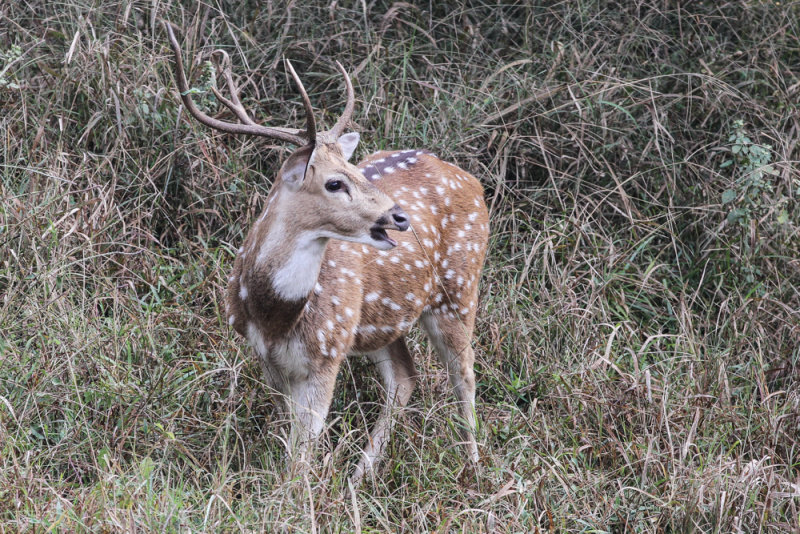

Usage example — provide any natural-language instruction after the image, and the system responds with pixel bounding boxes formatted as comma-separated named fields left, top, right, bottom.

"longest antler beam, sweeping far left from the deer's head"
left=164, top=21, right=314, bottom=146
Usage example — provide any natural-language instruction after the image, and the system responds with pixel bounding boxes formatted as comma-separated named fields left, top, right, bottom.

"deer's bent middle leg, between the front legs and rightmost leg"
left=352, top=338, right=417, bottom=482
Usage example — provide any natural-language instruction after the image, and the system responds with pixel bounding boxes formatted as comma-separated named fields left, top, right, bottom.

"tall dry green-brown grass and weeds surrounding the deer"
left=0, top=0, right=800, bottom=532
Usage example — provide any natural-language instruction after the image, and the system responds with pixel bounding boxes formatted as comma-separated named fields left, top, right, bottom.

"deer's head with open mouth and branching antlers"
left=165, top=23, right=409, bottom=250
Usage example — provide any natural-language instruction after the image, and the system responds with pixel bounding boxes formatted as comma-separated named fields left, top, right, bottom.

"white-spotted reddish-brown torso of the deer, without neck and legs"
left=306, top=151, right=489, bottom=357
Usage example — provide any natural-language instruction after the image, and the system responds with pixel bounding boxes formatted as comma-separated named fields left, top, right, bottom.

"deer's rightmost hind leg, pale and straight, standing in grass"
left=420, top=312, right=479, bottom=464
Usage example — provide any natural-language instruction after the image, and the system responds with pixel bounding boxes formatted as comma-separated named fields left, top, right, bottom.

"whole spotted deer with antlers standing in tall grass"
left=165, top=23, right=489, bottom=482
